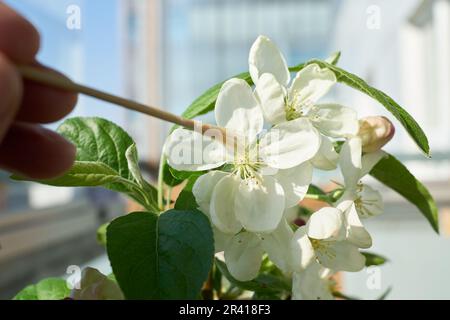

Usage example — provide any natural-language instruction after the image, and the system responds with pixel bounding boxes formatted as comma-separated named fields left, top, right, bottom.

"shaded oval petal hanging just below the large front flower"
left=225, top=232, right=264, bottom=281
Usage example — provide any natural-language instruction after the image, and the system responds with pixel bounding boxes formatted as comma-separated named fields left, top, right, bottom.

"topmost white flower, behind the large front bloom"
left=249, top=36, right=359, bottom=170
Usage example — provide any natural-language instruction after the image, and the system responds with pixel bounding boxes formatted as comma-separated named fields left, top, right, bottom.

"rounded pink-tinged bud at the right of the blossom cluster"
left=358, top=116, right=395, bottom=152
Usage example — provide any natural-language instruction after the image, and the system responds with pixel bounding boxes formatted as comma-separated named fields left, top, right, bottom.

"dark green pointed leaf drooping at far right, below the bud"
left=370, top=155, right=439, bottom=233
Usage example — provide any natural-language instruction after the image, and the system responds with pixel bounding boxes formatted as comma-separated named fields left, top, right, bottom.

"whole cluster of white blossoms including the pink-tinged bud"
left=164, top=36, right=393, bottom=299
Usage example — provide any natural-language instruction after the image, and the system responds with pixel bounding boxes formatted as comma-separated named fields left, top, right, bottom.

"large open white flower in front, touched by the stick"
left=164, top=79, right=320, bottom=235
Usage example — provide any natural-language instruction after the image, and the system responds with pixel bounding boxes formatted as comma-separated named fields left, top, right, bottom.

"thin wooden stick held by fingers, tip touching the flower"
left=17, top=65, right=226, bottom=137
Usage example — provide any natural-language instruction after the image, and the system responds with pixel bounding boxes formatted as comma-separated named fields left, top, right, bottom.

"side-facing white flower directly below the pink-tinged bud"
left=339, top=137, right=386, bottom=218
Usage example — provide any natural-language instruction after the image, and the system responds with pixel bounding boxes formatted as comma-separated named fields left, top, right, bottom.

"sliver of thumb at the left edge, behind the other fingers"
left=0, top=52, right=22, bottom=143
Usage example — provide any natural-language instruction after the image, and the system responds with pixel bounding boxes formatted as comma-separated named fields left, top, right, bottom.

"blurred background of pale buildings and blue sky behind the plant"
left=0, top=0, right=450, bottom=299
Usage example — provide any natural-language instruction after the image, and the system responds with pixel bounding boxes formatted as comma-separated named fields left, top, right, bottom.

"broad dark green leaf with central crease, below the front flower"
left=107, top=210, right=214, bottom=299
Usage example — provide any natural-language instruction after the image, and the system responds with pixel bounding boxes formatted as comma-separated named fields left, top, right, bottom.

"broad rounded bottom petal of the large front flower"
left=236, top=176, right=285, bottom=232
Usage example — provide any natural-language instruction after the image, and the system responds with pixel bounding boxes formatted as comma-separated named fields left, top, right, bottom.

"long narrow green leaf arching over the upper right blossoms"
left=307, top=59, right=430, bottom=156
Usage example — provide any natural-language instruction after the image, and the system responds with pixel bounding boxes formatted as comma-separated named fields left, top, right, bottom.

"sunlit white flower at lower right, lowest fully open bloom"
left=290, top=201, right=372, bottom=272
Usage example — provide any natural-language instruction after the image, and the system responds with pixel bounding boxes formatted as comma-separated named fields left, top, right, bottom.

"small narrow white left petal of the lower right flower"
left=290, top=227, right=315, bottom=272
